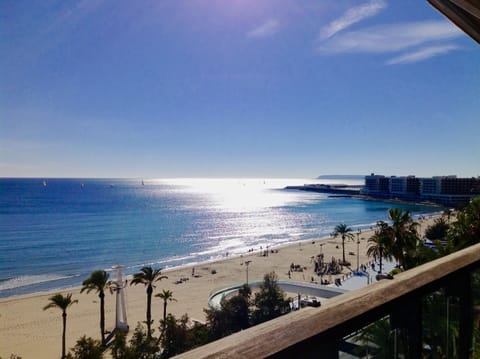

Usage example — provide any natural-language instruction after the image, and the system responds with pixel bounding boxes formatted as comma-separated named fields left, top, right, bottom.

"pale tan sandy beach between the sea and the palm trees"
left=0, top=217, right=434, bottom=359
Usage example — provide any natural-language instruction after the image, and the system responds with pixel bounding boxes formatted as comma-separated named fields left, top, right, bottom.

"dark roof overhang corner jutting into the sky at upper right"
left=428, top=0, right=480, bottom=44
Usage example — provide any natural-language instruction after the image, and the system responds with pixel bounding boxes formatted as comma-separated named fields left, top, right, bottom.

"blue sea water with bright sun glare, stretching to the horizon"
left=0, top=179, right=439, bottom=297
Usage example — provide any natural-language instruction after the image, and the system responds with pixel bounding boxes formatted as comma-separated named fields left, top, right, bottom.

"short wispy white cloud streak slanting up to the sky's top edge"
left=320, top=0, right=387, bottom=39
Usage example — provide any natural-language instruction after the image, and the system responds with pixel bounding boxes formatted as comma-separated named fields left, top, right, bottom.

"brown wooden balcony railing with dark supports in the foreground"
left=174, top=244, right=480, bottom=359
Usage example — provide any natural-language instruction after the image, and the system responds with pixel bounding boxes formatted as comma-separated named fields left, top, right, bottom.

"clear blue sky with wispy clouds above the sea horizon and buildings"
left=0, top=0, right=480, bottom=178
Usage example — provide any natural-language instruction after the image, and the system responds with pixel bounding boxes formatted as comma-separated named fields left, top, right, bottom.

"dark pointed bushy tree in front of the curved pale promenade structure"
left=253, top=272, right=290, bottom=324
